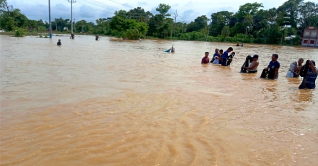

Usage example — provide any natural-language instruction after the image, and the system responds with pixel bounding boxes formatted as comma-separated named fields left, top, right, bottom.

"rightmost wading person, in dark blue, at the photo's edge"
left=299, top=60, right=318, bottom=89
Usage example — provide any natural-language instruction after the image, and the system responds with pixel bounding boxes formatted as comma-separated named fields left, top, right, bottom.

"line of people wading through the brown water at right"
left=201, top=47, right=318, bottom=89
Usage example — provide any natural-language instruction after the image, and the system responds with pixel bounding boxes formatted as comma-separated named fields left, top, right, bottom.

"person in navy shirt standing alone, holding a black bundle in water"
left=261, top=54, right=280, bottom=79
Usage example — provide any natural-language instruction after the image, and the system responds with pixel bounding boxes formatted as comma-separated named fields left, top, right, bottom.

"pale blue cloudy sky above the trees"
left=8, top=0, right=318, bottom=23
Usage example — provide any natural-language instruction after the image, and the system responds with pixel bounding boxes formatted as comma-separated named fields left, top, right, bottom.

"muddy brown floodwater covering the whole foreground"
left=0, top=36, right=318, bottom=166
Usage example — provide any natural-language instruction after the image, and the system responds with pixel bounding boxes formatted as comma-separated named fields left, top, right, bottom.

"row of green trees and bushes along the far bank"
left=0, top=0, right=318, bottom=45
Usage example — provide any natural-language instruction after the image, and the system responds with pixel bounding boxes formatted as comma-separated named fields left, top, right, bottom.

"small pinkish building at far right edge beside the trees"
left=301, top=27, right=318, bottom=47
